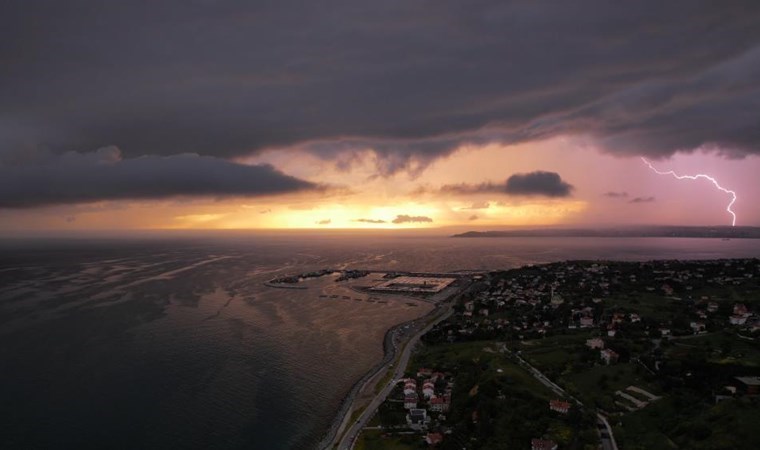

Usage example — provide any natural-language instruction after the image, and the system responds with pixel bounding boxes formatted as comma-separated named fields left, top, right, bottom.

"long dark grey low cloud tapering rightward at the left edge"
left=0, top=147, right=319, bottom=208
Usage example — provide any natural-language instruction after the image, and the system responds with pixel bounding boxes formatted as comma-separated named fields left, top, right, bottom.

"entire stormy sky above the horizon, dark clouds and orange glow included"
left=0, top=0, right=760, bottom=231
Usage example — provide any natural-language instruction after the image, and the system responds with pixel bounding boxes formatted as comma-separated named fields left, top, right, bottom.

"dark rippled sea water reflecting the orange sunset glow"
left=0, top=233, right=760, bottom=450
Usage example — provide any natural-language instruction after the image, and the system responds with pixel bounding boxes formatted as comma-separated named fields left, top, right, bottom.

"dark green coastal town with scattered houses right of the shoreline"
left=355, top=259, right=760, bottom=450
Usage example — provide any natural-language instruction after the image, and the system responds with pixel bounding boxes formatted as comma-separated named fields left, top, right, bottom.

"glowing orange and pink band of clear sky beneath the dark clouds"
left=0, top=138, right=760, bottom=230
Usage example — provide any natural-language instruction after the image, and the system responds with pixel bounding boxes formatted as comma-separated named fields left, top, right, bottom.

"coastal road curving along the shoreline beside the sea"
left=337, top=303, right=454, bottom=450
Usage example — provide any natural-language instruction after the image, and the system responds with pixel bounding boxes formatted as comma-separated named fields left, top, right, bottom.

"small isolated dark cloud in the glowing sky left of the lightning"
left=440, top=170, right=574, bottom=197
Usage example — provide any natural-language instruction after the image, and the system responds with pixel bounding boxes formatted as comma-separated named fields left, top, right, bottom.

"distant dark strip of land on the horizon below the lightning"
left=452, top=226, right=760, bottom=239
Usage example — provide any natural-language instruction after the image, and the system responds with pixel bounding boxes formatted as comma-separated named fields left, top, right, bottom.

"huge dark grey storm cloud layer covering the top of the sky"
left=0, top=0, right=760, bottom=175
